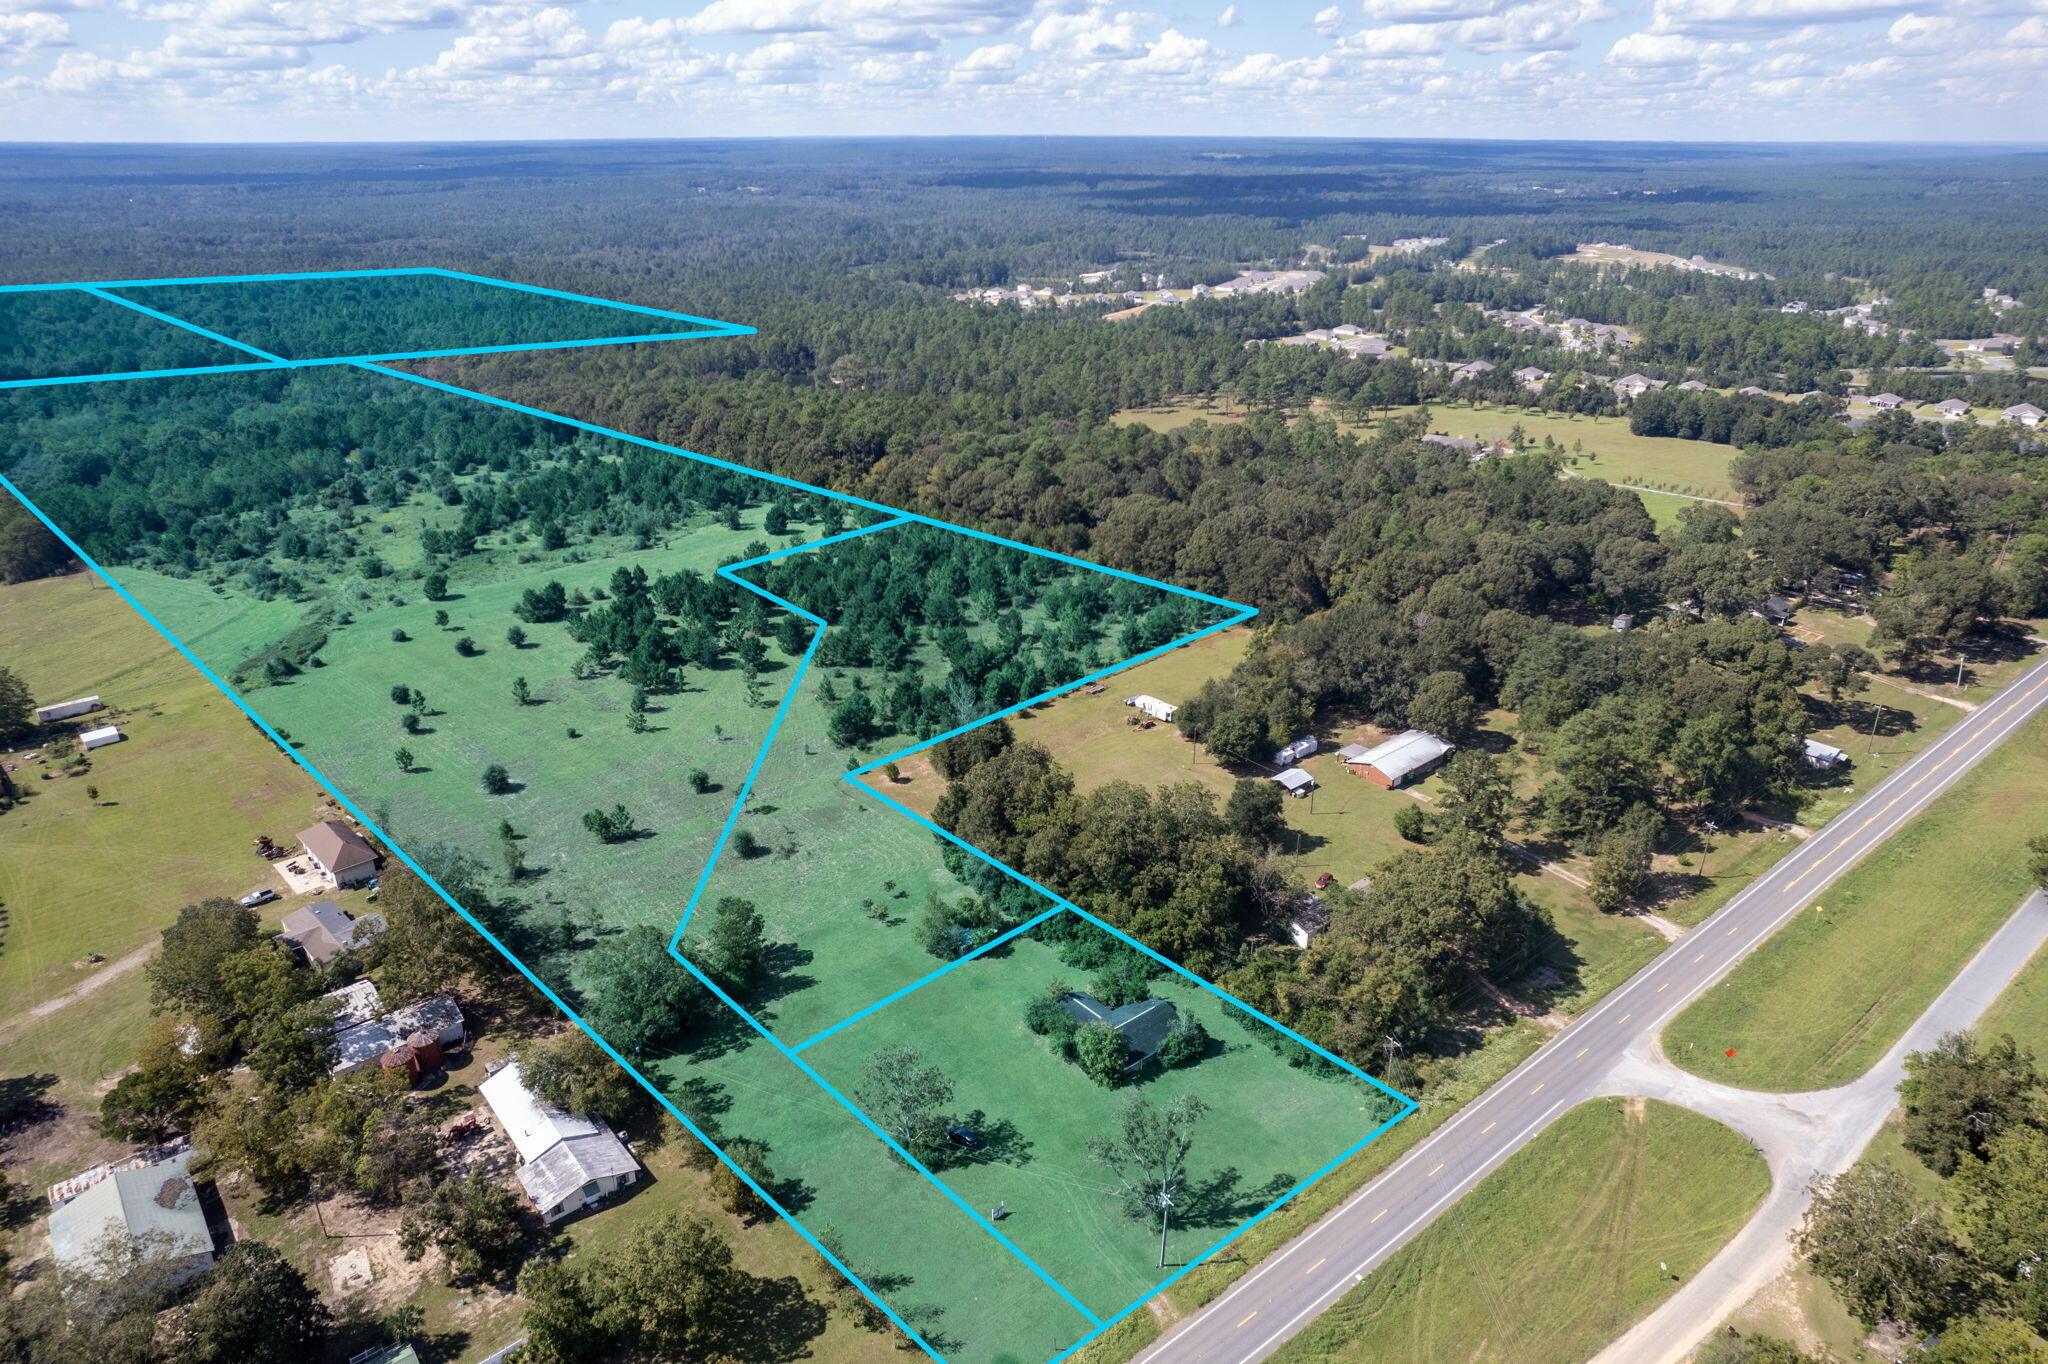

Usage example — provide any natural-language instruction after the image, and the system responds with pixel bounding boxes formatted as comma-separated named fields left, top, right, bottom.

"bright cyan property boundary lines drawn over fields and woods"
left=0, top=268, right=1417, bottom=1364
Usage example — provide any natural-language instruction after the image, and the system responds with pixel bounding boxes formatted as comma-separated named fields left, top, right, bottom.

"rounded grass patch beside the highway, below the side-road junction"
left=1274, top=1100, right=1769, bottom=1364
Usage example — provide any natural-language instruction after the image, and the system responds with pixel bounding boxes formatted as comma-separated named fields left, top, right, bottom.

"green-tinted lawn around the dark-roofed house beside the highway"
left=803, top=925, right=1397, bottom=1317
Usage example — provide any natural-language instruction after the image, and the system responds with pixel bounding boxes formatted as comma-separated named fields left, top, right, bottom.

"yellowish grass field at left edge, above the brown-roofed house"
left=0, top=573, right=322, bottom=1024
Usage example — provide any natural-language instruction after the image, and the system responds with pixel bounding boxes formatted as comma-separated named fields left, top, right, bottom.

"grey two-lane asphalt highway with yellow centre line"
left=1139, top=647, right=2048, bottom=1364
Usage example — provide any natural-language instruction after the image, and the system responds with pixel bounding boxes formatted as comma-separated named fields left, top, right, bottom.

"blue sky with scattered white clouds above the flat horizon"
left=0, top=0, right=2048, bottom=141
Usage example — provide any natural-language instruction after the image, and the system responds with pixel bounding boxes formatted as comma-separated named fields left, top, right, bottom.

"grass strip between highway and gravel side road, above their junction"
left=1663, top=717, right=2048, bottom=1092
